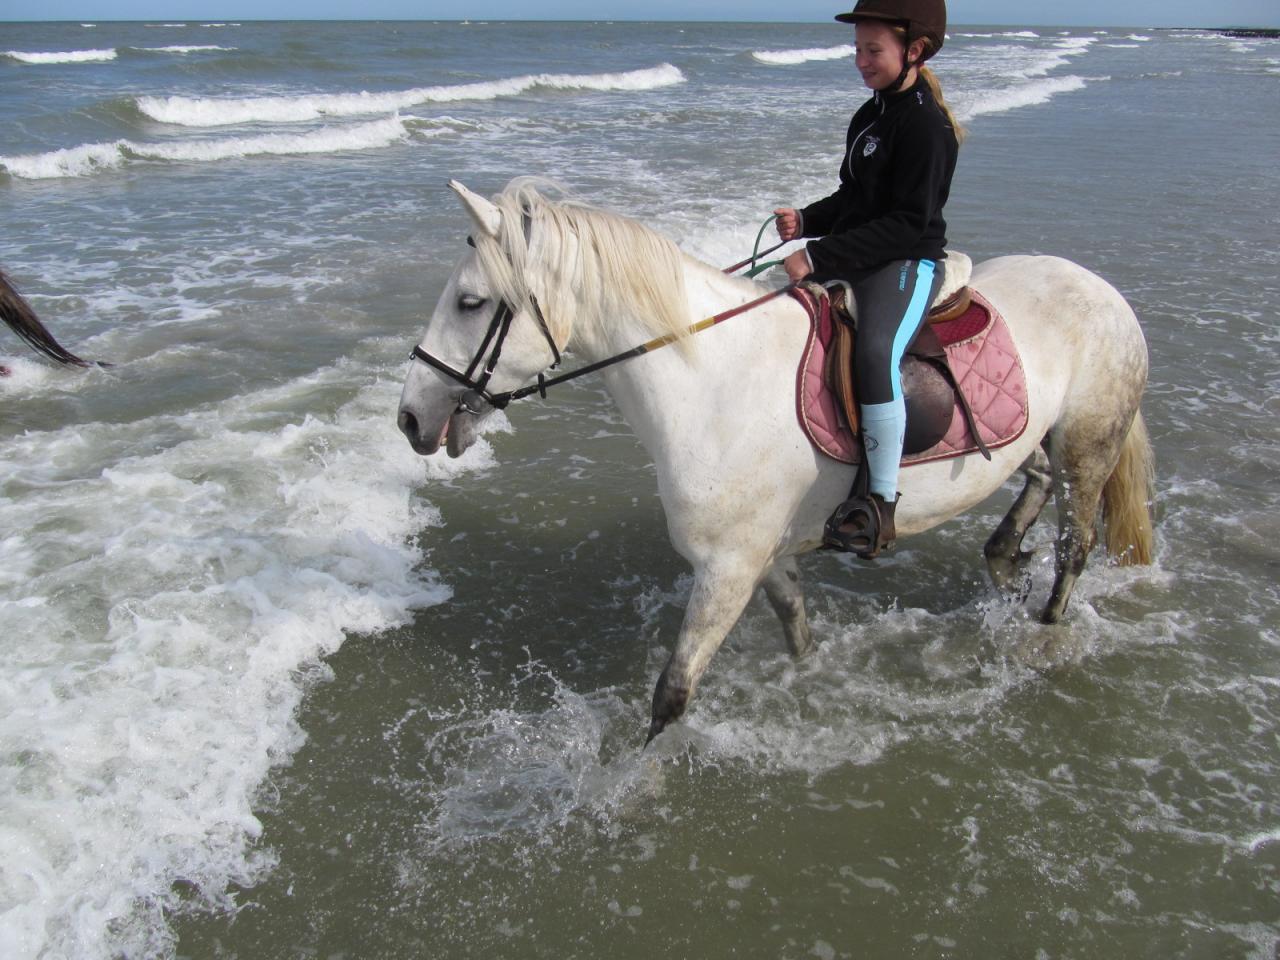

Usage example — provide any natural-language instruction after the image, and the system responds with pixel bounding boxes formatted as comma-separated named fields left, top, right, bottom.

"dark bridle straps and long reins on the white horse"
left=410, top=216, right=796, bottom=416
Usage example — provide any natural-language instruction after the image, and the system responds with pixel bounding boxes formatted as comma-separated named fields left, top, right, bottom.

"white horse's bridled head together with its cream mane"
left=398, top=177, right=689, bottom=457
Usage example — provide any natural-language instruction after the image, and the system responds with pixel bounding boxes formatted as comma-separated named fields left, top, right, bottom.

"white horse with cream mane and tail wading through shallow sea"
left=398, top=178, right=1152, bottom=740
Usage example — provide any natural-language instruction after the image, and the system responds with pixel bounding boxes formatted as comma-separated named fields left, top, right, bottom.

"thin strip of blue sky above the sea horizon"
left=0, top=0, right=1280, bottom=27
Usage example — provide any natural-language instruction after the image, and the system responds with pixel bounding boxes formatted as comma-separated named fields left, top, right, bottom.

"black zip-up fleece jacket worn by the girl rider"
left=800, top=78, right=957, bottom=283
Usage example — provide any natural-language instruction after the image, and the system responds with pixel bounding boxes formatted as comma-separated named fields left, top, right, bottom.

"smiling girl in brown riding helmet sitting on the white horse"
left=774, top=0, right=963, bottom=557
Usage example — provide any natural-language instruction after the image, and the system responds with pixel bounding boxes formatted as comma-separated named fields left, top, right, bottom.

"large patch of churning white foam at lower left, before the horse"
left=0, top=365, right=492, bottom=959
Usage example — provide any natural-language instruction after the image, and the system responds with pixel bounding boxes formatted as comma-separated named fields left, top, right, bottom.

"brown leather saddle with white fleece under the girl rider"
left=810, top=253, right=991, bottom=460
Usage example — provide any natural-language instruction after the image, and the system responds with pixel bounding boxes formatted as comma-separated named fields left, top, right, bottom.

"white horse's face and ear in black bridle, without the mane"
left=397, top=180, right=559, bottom=457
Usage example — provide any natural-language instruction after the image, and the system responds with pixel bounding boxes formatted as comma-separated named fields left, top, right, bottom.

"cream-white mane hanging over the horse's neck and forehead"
left=475, top=177, right=706, bottom=355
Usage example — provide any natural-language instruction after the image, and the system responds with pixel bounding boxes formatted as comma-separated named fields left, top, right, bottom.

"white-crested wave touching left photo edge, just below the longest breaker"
left=0, top=115, right=408, bottom=180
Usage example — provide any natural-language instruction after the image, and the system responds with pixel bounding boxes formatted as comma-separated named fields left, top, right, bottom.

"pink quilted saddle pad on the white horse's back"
left=792, top=288, right=1028, bottom=466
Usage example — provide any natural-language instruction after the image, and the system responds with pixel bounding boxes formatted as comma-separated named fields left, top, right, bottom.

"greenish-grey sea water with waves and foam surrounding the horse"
left=0, top=22, right=1280, bottom=957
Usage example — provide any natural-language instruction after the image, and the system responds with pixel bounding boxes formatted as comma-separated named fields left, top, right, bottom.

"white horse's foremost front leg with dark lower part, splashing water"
left=645, top=561, right=763, bottom=744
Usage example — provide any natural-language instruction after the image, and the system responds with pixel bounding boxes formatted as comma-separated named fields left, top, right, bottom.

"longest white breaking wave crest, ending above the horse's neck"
left=137, top=63, right=685, bottom=127
